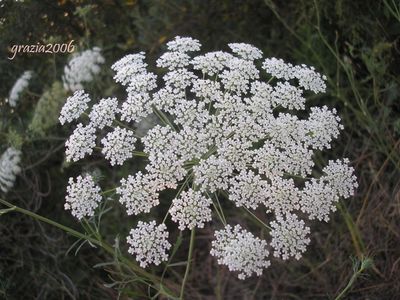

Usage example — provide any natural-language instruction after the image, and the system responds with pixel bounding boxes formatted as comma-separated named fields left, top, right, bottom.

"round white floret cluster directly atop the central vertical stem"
left=169, top=189, right=212, bottom=230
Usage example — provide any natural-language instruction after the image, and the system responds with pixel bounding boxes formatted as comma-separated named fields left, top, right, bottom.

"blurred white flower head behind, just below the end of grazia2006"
left=63, top=47, right=105, bottom=92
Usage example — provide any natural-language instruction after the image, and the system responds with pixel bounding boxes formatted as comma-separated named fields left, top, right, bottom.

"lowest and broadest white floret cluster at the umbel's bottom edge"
left=210, top=225, right=271, bottom=279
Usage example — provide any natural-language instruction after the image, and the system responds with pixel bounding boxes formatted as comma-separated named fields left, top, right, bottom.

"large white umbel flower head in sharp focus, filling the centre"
left=62, top=37, right=357, bottom=279
